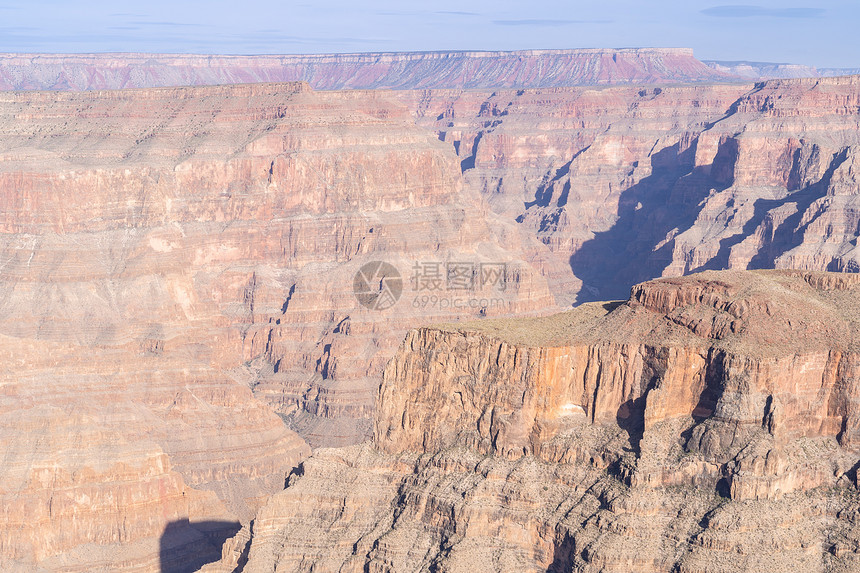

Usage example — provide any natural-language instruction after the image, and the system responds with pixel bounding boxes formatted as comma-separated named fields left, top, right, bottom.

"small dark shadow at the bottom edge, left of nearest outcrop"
left=158, top=519, right=242, bottom=573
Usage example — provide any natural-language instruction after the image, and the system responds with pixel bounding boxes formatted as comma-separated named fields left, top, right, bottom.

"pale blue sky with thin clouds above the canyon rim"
left=0, top=0, right=860, bottom=67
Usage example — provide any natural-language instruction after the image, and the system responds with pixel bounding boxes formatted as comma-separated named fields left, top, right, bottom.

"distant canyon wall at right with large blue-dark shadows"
left=395, top=76, right=860, bottom=302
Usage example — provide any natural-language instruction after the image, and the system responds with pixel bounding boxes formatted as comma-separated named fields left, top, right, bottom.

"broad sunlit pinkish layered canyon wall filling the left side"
left=0, top=84, right=557, bottom=572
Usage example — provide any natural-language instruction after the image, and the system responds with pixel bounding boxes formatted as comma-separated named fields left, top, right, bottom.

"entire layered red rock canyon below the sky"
left=0, top=49, right=860, bottom=573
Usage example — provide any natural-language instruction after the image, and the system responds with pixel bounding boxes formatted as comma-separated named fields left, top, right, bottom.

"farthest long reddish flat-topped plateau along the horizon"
left=0, top=48, right=739, bottom=91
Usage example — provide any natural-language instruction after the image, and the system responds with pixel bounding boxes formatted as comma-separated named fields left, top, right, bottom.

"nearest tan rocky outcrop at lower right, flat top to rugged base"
left=204, top=271, right=860, bottom=573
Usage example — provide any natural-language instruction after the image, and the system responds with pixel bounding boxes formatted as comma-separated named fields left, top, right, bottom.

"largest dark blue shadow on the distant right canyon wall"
left=570, top=140, right=737, bottom=303
